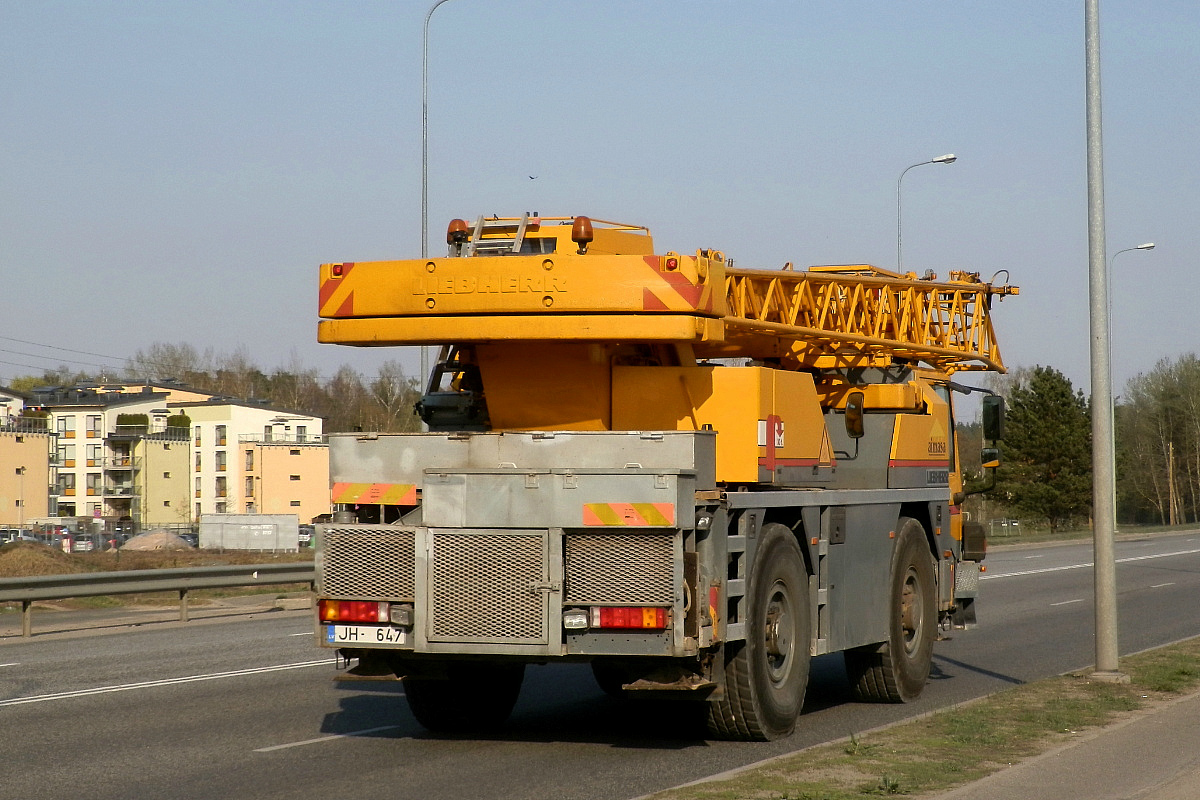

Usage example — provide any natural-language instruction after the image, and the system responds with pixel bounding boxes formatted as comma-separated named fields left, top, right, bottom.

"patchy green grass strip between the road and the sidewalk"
left=654, top=638, right=1200, bottom=800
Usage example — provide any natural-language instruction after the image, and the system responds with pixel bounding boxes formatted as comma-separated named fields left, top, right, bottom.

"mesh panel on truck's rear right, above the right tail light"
left=563, top=533, right=674, bottom=604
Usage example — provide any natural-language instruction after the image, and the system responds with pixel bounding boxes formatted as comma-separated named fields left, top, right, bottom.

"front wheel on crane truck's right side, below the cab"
left=845, top=517, right=937, bottom=703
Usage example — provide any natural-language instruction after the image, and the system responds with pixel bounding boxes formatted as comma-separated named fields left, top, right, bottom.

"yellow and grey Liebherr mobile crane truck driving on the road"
left=317, top=215, right=1018, bottom=740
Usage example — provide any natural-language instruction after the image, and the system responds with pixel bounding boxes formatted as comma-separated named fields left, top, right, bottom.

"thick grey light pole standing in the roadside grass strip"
left=1084, top=0, right=1129, bottom=682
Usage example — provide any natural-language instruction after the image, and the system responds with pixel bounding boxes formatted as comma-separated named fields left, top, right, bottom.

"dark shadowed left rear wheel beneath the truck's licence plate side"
left=404, top=663, right=524, bottom=733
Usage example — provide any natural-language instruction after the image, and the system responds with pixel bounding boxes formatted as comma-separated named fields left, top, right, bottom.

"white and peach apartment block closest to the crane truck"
left=168, top=397, right=331, bottom=523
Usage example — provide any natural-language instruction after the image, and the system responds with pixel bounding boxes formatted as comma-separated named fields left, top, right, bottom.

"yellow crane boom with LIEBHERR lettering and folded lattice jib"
left=318, top=215, right=1018, bottom=372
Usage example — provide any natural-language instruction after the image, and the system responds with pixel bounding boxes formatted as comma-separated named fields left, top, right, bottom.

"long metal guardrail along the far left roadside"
left=0, top=564, right=317, bottom=637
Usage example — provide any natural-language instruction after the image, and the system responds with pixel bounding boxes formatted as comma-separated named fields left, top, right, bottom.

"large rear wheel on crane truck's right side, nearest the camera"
left=708, top=523, right=810, bottom=741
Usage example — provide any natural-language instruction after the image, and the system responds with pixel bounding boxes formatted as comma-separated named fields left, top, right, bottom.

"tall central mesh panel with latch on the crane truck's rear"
left=430, top=531, right=547, bottom=643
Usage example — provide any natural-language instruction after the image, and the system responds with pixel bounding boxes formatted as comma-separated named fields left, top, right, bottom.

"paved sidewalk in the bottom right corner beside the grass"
left=922, top=692, right=1200, bottom=800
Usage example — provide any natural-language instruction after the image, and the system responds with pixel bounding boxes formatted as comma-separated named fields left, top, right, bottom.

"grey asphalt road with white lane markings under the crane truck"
left=7, top=534, right=1200, bottom=800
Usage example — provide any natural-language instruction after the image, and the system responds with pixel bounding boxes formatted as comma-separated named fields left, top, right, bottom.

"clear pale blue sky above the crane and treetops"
left=0, top=0, right=1200, bottom=393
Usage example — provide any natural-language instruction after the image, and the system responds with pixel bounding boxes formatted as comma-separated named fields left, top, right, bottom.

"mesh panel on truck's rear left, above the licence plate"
left=318, top=525, right=415, bottom=600
